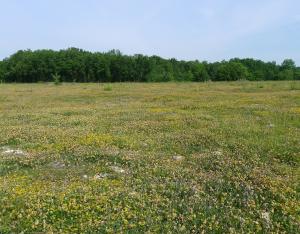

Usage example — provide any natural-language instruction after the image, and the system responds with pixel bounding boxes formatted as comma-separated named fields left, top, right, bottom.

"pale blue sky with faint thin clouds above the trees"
left=0, top=0, right=300, bottom=66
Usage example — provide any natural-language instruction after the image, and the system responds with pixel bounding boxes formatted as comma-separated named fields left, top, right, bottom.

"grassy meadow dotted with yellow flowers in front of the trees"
left=0, top=81, right=300, bottom=234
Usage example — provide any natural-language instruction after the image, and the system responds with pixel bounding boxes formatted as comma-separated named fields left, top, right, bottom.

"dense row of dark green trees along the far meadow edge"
left=0, top=48, right=300, bottom=83
